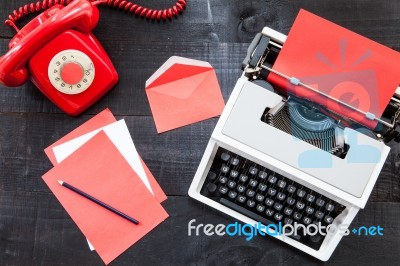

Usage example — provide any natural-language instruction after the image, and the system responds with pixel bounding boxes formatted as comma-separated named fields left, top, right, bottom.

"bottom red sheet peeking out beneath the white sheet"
left=44, top=109, right=167, bottom=202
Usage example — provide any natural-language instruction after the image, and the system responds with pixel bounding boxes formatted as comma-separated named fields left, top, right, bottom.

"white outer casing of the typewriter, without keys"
left=189, top=27, right=390, bottom=261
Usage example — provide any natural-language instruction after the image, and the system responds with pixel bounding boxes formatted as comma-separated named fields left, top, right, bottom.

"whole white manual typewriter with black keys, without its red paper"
left=189, top=27, right=400, bottom=261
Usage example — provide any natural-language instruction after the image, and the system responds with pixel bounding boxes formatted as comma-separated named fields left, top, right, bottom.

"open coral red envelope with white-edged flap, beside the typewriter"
left=146, top=56, right=225, bottom=133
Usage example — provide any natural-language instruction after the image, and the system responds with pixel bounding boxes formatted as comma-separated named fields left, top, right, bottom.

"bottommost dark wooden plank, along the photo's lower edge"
left=0, top=192, right=400, bottom=265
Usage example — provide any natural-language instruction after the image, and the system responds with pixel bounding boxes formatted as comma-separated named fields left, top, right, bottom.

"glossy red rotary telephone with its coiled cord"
left=0, top=0, right=186, bottom=116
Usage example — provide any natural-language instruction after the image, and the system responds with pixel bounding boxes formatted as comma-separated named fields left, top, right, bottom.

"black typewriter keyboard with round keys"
left=201, top=148, right=345, bottom=250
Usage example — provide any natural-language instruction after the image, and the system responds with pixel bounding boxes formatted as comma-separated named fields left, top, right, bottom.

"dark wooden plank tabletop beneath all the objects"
left=0, top=0, right=400, bottom=265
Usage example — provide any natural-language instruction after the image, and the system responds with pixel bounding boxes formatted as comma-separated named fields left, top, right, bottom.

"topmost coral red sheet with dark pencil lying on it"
left=43, top=131, right=168, bottom=264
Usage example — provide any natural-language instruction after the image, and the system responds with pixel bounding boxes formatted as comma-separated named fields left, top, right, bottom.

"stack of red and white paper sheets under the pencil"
left=43, top=109, right=168, bottom=264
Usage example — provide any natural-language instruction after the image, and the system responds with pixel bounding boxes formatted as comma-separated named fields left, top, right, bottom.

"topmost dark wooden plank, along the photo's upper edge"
left=0, top=0, right=400, bottom=49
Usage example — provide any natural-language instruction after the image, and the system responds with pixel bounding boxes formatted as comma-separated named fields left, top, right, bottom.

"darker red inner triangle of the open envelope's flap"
left=146, top=63, right=213, bottom=89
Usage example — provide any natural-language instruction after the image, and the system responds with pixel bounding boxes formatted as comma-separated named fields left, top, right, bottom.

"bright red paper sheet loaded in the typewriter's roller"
left=268, top=10, right=400, bottom=128
